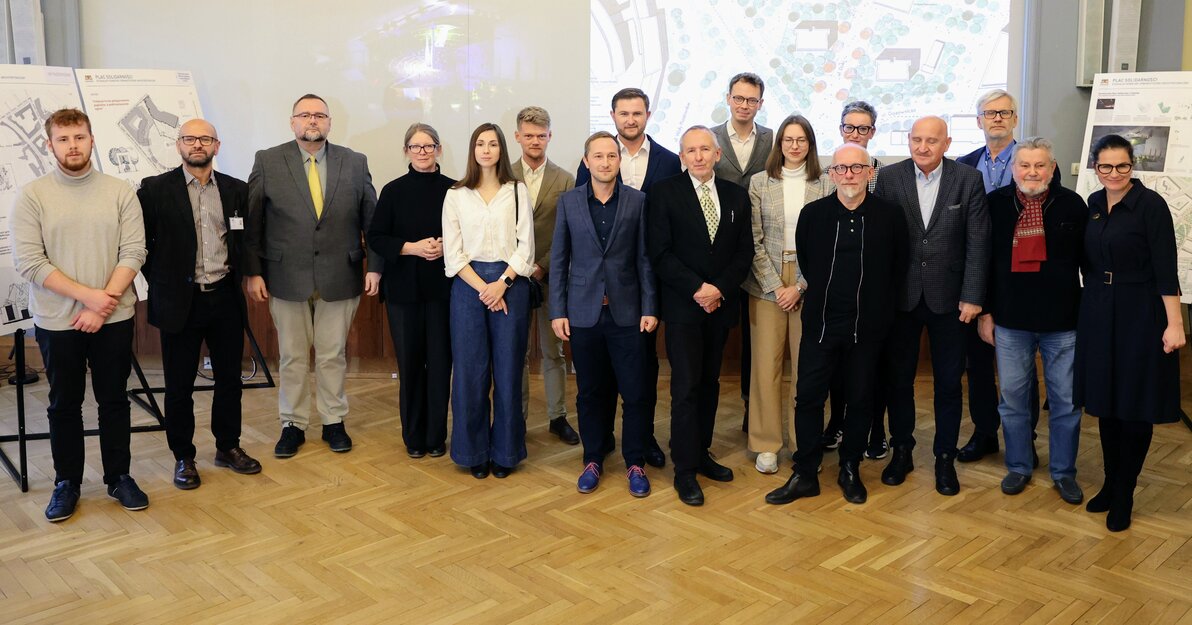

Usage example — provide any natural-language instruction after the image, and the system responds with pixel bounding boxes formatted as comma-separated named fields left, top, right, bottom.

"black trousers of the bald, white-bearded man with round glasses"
left=795, top=334, right=882, bottom=476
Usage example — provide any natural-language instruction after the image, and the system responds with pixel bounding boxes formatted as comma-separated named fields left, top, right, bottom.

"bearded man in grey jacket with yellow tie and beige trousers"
left=244, top=93, right=374, bottom=458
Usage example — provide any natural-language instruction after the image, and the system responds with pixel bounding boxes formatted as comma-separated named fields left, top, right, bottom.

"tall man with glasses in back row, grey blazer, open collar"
left=712, top=72, right=774, bottom=431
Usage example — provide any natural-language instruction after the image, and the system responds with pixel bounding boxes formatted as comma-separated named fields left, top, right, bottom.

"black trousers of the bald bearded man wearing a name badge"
left=161, top=285, right=244, bottom=460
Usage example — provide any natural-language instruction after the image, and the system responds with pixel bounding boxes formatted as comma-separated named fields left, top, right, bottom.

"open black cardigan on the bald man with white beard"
left=795, top=193, right=909, bottom=342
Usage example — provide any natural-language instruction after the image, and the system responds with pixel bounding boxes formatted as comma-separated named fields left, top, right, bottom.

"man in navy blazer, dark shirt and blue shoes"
left=548, top=131, right=658, bottom=497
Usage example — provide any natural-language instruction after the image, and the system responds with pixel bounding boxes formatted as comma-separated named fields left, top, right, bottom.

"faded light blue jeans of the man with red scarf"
left=994, top=326, right=1080, bottom=479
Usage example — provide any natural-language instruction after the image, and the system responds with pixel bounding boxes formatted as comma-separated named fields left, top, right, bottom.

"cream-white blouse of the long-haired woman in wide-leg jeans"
left=443, top=182, right=534, bottom=278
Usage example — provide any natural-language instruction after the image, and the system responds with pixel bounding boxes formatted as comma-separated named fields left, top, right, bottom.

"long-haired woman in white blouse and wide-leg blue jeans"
left=443, top=124, right=534, bottom=478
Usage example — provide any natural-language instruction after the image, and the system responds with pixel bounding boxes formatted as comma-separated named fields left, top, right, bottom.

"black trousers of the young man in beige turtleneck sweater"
left=35, top=318, right=134, bottom=484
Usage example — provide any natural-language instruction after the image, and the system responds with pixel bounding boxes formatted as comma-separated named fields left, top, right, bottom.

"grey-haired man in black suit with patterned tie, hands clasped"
left=647, top=126, right=753, bottom=506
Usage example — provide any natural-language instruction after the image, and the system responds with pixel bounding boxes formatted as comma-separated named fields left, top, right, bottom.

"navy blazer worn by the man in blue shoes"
left=550, top=181, right=658, bottom=328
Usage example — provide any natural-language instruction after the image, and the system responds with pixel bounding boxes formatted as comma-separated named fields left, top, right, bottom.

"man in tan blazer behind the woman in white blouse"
left=513, top=106, right=579, bottom=445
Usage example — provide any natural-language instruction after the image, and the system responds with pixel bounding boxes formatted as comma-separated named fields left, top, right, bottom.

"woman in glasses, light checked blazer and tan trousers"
left=741, top=115, right=831, bottom=474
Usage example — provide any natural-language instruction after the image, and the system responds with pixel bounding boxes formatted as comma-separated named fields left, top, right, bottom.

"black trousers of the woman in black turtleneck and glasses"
left=385, top=299, right=452, bottom=451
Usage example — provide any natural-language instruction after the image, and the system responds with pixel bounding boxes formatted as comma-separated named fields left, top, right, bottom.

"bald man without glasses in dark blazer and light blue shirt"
left=875, top=117, right=991, bottom=495
